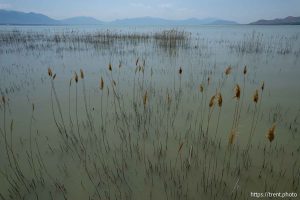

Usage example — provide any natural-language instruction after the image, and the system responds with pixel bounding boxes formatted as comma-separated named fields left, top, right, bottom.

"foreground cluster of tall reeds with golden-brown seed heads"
left=0, top=38, right=300, bottom=199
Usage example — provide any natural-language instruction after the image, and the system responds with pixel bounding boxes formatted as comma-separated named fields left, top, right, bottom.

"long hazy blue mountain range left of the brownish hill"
left=0, top=10, right=238, bottom=25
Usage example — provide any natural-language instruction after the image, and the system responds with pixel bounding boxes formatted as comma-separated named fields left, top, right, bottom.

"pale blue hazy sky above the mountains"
left=0, top=0, right=300, bottom=23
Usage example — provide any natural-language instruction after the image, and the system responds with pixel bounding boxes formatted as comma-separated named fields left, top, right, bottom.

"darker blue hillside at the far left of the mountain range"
left=0, top=10, right=60, bottom=25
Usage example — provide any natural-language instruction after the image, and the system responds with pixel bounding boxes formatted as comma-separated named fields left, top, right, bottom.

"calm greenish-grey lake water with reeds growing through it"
left=0, top=25, right=300, bottom=199
